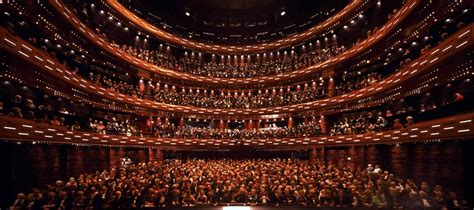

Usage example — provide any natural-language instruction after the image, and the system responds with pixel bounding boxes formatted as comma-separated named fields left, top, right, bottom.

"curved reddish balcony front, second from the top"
left=50, top=0, right=419, bottom=85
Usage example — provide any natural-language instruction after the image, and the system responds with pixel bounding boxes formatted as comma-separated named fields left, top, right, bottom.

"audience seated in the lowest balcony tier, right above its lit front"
left=0, top=76, right=470, bottom=140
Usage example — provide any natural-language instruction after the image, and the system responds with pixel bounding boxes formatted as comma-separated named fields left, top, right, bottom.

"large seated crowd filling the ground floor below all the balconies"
left=11, top=158, right=468, bottom=210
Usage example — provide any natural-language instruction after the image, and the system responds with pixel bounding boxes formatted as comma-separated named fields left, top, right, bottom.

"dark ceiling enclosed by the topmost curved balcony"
left=121, top=0, right=350, bottom=44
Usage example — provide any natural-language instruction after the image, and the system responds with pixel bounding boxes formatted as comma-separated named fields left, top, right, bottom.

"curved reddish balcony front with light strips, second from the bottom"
left=1, top=24, right=474, bottom=118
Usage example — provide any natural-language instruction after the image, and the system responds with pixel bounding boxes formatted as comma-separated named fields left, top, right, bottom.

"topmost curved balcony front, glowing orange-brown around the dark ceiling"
left=106, top=0, right=367, bottom=54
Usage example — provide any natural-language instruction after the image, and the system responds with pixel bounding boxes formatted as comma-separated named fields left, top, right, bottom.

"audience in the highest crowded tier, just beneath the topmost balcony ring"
left=116, top=44, right=346, bottom=78
